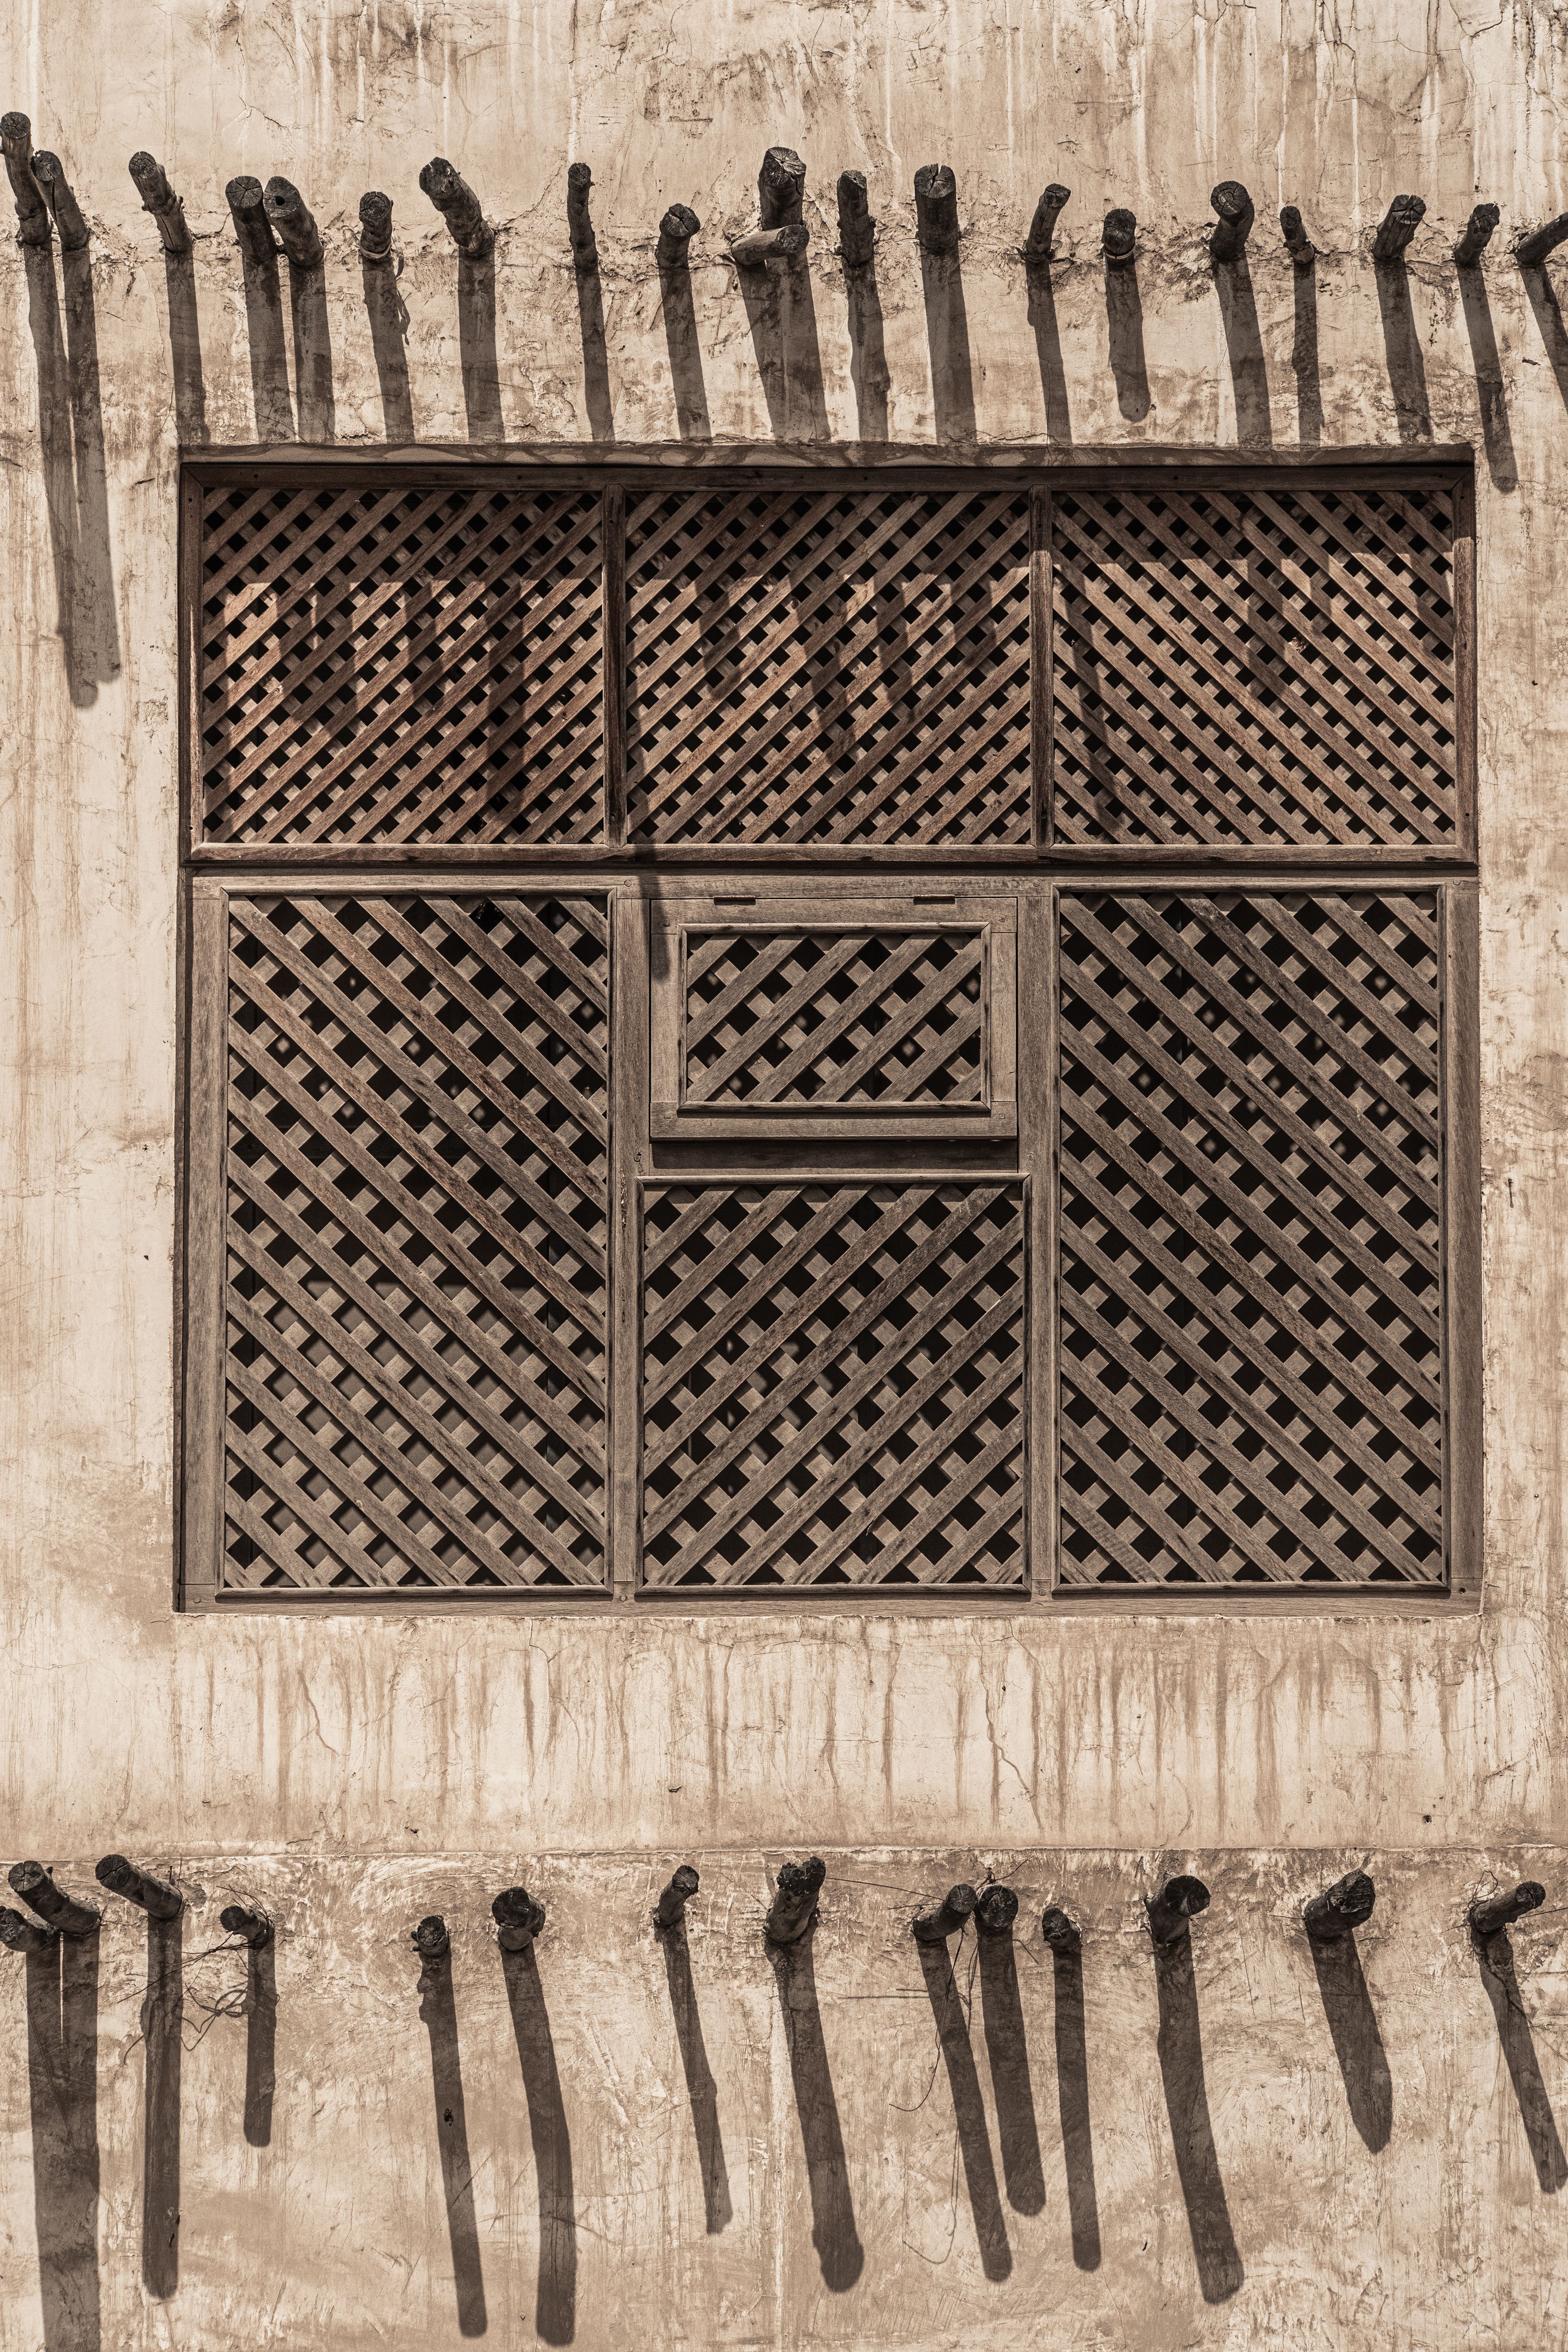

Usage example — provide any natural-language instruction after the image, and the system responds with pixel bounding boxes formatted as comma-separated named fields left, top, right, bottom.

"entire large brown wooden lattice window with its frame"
left=181, top=449, right=1481, bottom=1611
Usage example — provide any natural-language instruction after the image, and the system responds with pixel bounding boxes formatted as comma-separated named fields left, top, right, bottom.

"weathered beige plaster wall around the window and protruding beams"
left=0, top=0, right=1568, bottom=2352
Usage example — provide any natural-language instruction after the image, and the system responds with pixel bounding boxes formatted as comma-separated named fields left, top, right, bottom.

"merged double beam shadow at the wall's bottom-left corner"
left=26, top=1933, right=104, bottom=2352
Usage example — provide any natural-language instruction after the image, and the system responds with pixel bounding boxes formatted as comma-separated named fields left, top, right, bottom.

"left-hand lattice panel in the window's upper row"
left=200, top=484, right=604, bottom=847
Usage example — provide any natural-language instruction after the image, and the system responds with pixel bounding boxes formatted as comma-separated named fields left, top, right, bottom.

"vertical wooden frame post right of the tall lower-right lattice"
left=1439, top=882, right=1486, bottom=1595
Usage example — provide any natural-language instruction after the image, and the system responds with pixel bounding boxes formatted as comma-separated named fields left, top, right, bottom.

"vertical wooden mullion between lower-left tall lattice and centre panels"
left=604, top=884, right=651, bottom=1602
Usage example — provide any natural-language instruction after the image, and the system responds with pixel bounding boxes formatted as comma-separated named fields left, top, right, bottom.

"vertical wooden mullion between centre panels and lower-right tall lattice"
left=1018, top=884, right=1055, bottom=1599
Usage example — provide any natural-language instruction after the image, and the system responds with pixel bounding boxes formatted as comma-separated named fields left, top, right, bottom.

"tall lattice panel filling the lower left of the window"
left=219, top=894, right=609, bottom=1592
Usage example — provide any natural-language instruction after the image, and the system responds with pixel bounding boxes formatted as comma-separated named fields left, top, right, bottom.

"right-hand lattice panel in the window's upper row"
left=1051, top=484, right=1458, bottom=849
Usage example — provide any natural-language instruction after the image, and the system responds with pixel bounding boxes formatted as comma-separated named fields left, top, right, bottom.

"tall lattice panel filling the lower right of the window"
left=1058, top=891, right=1446, bottom=1588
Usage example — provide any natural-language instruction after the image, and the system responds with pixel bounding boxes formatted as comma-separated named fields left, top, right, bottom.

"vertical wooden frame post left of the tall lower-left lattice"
left=181, top=882, right=228, bottom=1609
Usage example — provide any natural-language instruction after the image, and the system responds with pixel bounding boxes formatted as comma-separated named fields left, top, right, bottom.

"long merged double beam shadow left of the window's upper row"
left=21, top=244, right=120, bottom=710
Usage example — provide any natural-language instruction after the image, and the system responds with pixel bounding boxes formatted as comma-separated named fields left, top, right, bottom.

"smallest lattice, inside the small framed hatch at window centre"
left=684, top=924, right=985, bottom=1110
